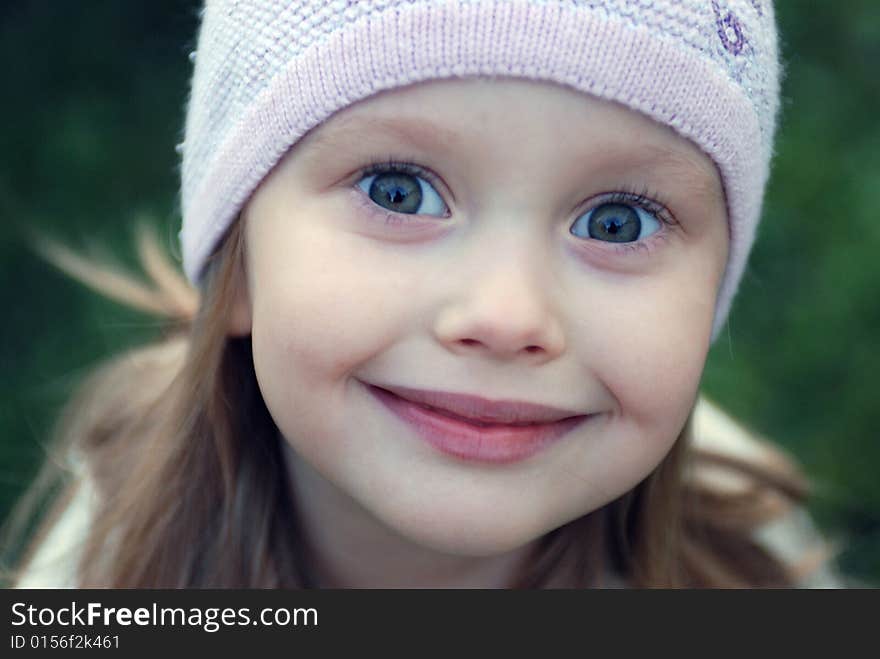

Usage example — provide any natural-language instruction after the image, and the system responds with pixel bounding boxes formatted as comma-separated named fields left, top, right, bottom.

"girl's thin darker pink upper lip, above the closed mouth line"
left=370, top=385, right=582, bottom=423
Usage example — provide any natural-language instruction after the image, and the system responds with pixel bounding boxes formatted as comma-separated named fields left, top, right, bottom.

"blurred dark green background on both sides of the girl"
left=0, top=0, right=880, bottom=584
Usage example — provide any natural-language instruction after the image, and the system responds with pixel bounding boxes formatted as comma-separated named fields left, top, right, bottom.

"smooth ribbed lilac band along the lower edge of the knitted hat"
left=180, top=1, right=772, bottom=340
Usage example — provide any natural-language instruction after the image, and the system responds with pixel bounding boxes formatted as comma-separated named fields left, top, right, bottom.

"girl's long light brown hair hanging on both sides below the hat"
left=7, top=220, right=820, bottom=588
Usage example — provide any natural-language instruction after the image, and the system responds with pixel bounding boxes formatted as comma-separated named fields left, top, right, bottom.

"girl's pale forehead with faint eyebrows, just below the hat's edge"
left=300, top=78, right=724, bottom=201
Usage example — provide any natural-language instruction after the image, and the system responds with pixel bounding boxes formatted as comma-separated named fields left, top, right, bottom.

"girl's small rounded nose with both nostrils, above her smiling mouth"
left=434, top=252, right=565, bottom=362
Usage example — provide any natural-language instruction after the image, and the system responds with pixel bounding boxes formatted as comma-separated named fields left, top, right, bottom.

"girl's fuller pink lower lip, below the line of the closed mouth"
left=368, top=386, right=590, bottom=463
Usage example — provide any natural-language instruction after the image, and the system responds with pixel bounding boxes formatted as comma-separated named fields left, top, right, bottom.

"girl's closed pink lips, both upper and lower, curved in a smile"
left=368, top=385, right=592, bottom=463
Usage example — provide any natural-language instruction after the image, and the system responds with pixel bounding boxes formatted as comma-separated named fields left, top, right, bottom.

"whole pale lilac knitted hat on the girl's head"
left=179, top=0, right=780, bottom=340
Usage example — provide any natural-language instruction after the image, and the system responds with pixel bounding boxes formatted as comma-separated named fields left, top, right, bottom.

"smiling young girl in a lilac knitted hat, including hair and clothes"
left=6, top=0, right=836, bottom=588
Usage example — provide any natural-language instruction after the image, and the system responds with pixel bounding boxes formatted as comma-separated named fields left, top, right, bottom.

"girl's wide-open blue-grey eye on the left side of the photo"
left=358, top=163, right=447, bottom=216
